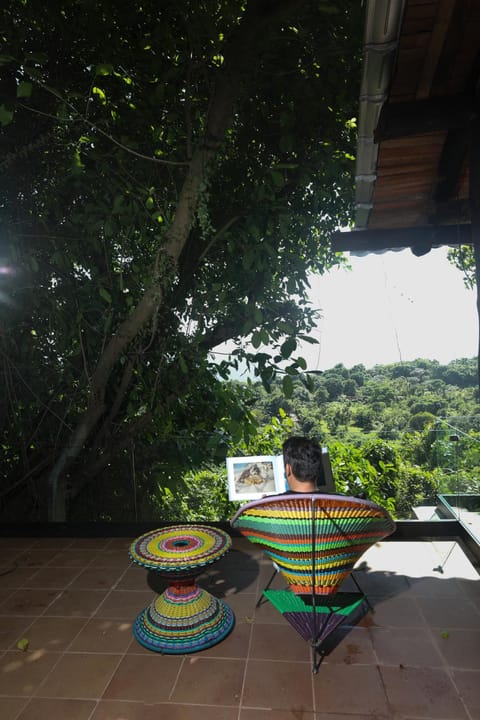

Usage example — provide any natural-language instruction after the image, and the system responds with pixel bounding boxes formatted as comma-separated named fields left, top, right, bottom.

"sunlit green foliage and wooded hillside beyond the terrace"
left=150, top=359, right=480, bottom=520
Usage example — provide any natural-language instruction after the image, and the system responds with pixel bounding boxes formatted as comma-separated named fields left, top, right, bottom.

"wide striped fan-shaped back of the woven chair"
left=231, top=493, right=395, bottom=595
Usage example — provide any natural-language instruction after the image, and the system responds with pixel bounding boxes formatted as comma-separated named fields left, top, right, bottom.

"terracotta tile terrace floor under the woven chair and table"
left=0, top=538, right=480, bottom=720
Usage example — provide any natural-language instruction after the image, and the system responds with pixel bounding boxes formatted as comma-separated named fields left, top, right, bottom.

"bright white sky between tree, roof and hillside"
left=300, top=248, right=478, bottom=370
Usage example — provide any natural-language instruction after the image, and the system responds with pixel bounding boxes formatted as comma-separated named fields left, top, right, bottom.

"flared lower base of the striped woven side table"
left=133, top=582, right=235, bottom=655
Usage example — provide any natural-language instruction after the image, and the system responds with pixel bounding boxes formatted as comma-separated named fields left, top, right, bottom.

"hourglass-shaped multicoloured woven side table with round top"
left=129, top=525, right=235, bottom=655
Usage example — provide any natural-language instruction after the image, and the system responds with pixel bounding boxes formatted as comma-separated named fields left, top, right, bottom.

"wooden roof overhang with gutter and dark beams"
left=333, top=0, right=480, bottom=254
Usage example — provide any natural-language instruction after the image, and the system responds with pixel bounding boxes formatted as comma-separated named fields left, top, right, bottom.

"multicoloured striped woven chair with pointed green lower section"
left=231, top=493, right=395, bottom=672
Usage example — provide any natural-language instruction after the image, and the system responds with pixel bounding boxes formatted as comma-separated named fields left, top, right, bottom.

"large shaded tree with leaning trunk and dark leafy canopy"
left=0, top=0, right=362, bottom=520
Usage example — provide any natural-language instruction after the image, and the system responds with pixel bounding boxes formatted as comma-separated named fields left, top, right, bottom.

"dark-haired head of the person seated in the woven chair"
left=283, top=437, right=323, bottom=492
